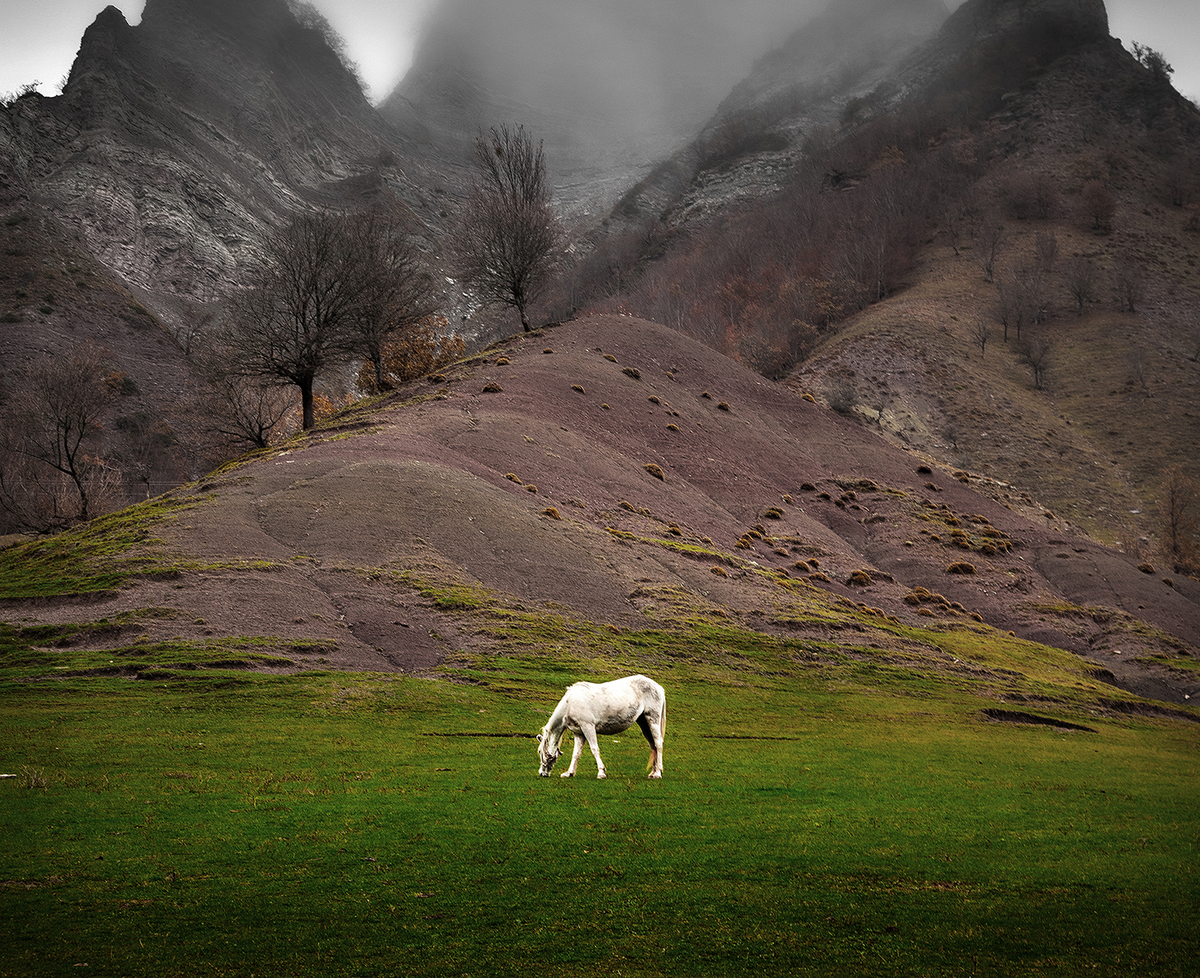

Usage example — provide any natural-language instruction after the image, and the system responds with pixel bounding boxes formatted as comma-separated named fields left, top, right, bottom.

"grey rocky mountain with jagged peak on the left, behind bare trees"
left=0, top=0, right=428, bottom=501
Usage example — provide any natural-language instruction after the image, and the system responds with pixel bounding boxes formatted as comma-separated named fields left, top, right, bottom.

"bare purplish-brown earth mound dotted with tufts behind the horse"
left=10, top=317, right=1200, bottom=700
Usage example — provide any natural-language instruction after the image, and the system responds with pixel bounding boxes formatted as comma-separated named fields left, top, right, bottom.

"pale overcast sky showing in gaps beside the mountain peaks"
left=0, top=0, right=1200, bottom=102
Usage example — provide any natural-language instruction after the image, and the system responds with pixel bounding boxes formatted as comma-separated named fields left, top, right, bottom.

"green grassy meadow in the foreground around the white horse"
left=0, top=617, right=1200, bottom=978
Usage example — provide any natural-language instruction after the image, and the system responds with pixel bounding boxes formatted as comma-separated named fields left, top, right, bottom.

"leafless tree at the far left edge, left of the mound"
left=0, top=346, right=120, bottom=530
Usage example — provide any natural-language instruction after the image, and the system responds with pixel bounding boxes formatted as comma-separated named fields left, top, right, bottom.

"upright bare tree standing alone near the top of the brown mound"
left=452, top=126, right=563, bottom=332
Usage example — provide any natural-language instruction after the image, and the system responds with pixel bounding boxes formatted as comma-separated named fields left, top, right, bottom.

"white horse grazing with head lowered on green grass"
left=538, top=676, right=667, bottom=778
